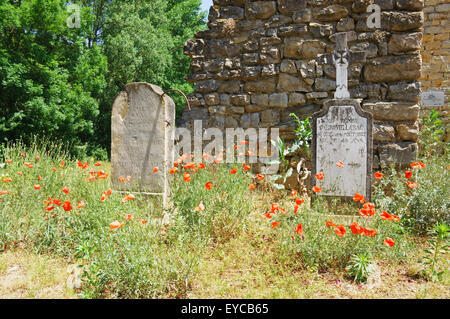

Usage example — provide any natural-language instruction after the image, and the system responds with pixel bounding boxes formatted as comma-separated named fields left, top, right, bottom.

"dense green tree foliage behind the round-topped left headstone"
left=0, top=0, right=205, bottom=158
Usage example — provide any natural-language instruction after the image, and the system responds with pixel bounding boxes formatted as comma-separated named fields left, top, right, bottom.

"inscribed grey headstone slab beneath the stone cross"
left=311, top=99, right=373, bottom=200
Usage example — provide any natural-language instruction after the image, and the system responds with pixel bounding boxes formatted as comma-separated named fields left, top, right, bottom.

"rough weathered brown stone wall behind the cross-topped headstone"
left=183, top=0, right=423, bottom=167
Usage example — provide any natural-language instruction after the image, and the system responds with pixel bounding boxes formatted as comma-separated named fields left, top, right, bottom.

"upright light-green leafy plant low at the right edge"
left=419, top=223, right=450, bottom=281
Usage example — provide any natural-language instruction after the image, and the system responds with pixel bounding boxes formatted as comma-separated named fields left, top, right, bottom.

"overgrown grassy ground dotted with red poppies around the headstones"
left=0, top=138, right=450, bottom=298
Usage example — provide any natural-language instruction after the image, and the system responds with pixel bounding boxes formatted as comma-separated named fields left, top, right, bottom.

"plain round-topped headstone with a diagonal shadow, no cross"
left=111, top=83, right=175, bottom=202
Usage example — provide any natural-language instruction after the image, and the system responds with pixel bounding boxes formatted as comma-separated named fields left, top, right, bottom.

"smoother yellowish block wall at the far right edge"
left=420, top=0, right=450, bottom=134
